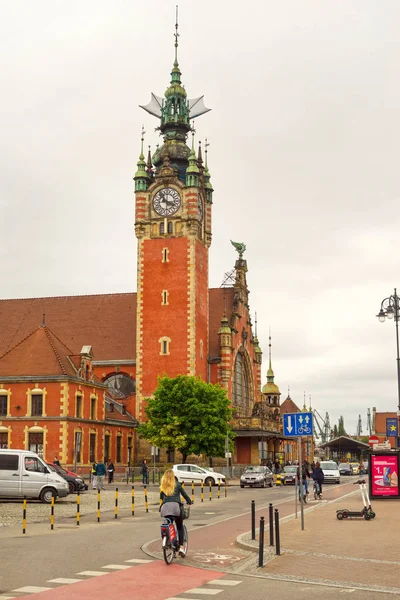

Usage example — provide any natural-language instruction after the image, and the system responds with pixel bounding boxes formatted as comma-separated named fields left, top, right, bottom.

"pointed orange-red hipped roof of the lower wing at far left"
left=0, top=326, right=77, bottom=377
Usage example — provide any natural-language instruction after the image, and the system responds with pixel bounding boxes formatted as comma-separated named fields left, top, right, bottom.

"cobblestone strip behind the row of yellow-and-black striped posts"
left=0, top=485, right=160, bottom=526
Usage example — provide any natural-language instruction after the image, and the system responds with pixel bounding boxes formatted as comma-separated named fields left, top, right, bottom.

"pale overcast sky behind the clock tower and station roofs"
left=0, top=0, right=400, bottom=433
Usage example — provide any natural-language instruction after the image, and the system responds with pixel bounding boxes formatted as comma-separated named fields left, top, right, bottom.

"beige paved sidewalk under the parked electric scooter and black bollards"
left=237, top=486, right=400, bottom=594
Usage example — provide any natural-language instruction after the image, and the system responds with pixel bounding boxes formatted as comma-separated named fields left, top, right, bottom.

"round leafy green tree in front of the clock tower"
left=138, top=375, right=234, bottom=462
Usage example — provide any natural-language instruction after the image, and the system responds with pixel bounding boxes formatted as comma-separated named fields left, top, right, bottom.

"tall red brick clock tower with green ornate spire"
left=134, top=21, right=213, bottom=421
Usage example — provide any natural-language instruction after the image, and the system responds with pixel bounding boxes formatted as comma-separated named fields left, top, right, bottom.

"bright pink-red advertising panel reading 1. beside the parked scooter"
left=369, top=452, right=400, bottom=498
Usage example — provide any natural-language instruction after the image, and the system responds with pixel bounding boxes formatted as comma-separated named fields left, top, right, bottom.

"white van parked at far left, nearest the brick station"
left=0, top=449, right=69, bottom=504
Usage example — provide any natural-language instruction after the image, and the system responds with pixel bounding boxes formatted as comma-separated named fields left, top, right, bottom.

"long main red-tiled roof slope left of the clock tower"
left=0, top=293, right=136, bottom=360
